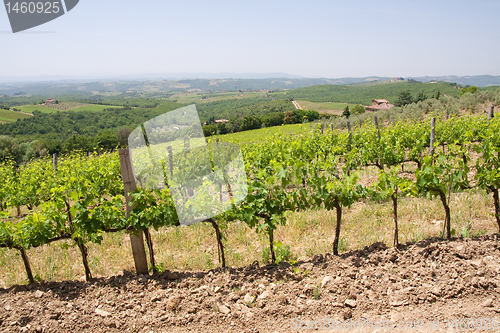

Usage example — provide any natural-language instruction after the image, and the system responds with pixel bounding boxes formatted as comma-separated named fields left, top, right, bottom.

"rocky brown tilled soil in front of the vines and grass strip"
left=0, top=234, right=500, bottom=332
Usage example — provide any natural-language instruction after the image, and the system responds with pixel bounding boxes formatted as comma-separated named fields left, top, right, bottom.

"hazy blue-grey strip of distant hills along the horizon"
left=0, top=73, right=500, bottom=102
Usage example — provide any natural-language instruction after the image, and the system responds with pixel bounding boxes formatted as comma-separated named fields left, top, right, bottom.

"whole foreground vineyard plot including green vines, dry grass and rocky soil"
left=0, top=83, right=500, bottom=333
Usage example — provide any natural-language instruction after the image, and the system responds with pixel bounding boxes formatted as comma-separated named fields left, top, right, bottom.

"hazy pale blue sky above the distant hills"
left=0, top=0, right=500, bottom=78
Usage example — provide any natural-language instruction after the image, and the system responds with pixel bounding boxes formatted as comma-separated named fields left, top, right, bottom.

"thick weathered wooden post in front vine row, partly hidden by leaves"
left=119, top=149, right=148, bottom=274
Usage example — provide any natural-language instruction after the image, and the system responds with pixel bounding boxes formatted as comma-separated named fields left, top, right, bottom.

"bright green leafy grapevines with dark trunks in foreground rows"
left=0, top=109, right=500, bottom=286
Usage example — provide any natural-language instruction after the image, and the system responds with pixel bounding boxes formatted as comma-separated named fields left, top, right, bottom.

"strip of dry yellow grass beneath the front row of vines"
left=0, top=190, right=498, bottom=287
